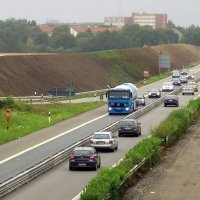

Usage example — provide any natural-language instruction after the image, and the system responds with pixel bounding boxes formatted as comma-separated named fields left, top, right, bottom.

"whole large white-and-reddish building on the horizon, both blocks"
left=104, top=13, right=167, bottom=29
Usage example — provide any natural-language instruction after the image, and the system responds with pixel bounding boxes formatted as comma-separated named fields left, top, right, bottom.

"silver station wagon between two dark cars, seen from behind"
left=90, top=131, right=118, bottom=152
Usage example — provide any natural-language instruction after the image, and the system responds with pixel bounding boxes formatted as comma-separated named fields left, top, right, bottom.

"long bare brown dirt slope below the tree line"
left=0, top=44, right=200, bottom=96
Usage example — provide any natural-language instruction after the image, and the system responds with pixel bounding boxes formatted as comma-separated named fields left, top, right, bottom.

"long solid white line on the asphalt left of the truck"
left=0, top=113, right=108, bottom=164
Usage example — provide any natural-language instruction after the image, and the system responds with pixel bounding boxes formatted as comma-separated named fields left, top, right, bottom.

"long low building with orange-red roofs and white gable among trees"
left=70, top=26, right=122, bottom=37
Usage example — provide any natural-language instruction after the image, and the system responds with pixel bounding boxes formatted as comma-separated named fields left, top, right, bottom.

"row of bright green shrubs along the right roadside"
left=81, top=99, right=200, bottom=200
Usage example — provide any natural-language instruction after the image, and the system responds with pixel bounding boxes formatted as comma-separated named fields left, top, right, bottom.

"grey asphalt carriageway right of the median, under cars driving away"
left=2, top=91, right=197, bottom=200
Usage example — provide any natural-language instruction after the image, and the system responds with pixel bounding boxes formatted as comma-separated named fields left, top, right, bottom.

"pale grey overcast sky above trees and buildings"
left=0, top=0, right=200, bottom=27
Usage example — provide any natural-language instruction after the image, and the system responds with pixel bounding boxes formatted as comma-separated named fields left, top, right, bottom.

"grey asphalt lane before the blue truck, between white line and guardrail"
left=0, top=112, right=124, bottom=182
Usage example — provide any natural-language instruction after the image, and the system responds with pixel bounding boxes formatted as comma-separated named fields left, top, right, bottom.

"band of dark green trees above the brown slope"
left=0, top=18, right=200, bottom=53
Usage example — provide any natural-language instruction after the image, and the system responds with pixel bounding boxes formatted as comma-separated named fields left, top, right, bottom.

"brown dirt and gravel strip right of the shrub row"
left=123, top=119, right=200, bottom=200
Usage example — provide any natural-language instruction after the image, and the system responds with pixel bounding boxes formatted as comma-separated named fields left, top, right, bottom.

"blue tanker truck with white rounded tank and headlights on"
left=106, top=83, right=138, bottom=115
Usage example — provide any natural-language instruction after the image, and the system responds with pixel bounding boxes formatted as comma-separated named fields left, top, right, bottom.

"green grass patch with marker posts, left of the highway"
left=0, top=97, right=105, bottom=144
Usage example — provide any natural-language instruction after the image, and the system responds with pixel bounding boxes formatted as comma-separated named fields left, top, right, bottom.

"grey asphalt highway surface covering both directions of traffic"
left=0, top=67, right=197, bottom=200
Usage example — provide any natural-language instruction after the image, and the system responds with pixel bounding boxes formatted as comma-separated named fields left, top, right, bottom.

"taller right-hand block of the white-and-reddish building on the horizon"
left=132, top=13, right=167, bottom=29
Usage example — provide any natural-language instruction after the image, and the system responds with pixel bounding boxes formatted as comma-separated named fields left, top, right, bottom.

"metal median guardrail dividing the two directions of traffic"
left=0, top=88, right=187, bottom=197
